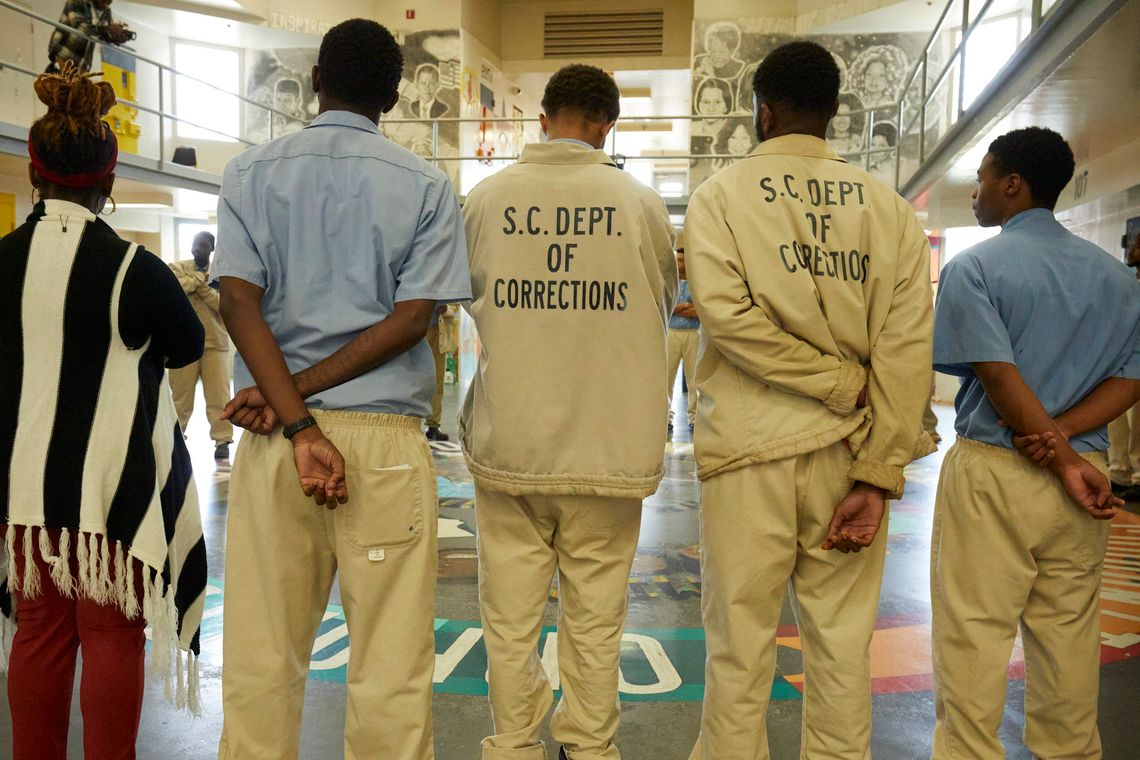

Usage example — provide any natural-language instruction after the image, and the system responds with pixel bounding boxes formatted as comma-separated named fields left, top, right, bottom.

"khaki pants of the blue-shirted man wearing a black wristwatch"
left=218, top=410, right=437, bottom=760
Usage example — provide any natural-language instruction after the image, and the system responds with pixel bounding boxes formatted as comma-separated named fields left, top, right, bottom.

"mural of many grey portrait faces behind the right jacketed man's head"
left=689, top=18, right=927, bottom=193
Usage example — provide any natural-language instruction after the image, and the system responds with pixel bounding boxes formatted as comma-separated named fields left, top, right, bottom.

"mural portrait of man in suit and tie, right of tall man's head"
left=380, top=30, right=462, bottom=187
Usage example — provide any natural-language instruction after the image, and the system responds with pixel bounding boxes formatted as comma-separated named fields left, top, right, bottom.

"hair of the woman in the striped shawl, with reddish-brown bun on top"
left=27, top=60, right=117, bottom=182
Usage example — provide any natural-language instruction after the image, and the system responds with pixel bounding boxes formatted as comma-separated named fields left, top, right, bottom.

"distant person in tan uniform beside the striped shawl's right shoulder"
left=170, top=232, right=234, bottom=461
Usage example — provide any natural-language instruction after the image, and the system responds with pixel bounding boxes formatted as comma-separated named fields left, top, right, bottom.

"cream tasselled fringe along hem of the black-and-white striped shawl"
left=0, top=524, right=202, bottom=717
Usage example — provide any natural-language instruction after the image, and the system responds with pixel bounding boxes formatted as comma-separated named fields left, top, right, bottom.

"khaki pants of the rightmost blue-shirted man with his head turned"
left=930, top=438, right=1108, bottom=760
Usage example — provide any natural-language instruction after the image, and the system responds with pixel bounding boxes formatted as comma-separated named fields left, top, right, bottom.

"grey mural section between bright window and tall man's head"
left=245, top=48, right=317, bottom=142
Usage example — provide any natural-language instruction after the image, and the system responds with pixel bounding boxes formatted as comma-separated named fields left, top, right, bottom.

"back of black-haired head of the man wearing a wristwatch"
left=317, top=18, right=404, bottom=113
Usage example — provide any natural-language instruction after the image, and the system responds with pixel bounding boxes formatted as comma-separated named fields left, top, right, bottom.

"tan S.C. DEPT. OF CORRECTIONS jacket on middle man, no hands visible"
left=459, top=141, right=677, bottom=498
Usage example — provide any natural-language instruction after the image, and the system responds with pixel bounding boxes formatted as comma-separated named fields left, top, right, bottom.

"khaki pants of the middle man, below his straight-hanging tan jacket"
left=475, top=485, right=642, bottom=760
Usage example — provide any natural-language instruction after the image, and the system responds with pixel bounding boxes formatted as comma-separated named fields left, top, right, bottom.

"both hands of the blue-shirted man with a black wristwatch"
left=221, top=386, right=349, bottom=509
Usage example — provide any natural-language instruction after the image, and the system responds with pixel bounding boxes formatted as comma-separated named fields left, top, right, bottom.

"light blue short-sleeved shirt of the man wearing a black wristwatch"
left=213, top=111, right=471, bottom=417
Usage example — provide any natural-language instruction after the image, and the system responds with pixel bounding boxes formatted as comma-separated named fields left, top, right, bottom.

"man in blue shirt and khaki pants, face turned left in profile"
left=930, top=128, right=1140, bottom=760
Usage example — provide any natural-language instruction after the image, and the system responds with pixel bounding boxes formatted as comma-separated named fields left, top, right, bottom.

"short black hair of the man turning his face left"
left=990, top=126, right=1076, bottom=209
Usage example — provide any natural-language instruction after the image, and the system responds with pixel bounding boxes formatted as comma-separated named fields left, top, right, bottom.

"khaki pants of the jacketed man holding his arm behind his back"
left=691, top=443, right=887, bottom=760
